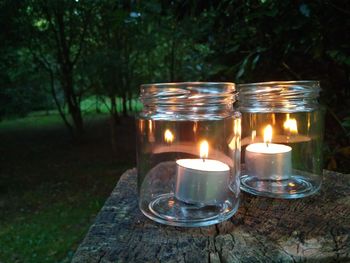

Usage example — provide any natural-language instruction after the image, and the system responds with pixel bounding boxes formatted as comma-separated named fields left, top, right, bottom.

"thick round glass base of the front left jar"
left=140, top=193, right=239, bottom=227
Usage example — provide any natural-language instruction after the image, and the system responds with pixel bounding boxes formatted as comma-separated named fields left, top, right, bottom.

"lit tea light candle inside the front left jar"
left=175, top=141, right=230, bottom=205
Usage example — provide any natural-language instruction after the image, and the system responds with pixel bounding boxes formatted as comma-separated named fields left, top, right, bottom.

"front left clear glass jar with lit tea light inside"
left=136, top=82, right=241, bottom=227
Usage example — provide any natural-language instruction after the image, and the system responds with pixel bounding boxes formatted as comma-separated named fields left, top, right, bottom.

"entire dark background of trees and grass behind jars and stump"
left=0, top=0, right=350, bottom=262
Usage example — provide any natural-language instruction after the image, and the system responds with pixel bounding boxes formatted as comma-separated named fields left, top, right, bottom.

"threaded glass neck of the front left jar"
left=140, top=82, right=236, bottom=120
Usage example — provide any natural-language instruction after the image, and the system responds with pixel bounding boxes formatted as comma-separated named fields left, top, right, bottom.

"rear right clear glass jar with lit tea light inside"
left=238, top=81, right=324, bottom=199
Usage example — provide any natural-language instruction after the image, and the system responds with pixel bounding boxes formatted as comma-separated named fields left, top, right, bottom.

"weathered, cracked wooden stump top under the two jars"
left=72, top=169, right=350, bottom=263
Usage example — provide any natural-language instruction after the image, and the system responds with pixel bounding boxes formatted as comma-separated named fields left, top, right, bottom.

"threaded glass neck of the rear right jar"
left=238, top=80, right=321, bottom=113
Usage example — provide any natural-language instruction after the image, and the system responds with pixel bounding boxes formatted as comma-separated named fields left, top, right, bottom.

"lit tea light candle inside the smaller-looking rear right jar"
left=245, top=125, right=292, bottom=180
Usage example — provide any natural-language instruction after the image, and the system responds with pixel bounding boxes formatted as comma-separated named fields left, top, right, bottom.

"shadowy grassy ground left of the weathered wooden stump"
left=0, top=113, right=135, bottom=263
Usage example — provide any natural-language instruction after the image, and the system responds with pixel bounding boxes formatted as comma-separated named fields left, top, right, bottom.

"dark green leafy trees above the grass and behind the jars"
left=0, top=0, right=350, bottom=158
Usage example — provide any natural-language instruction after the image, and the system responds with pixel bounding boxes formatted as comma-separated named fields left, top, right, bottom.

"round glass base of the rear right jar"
left=240, top=173, right=320, bottom=199
